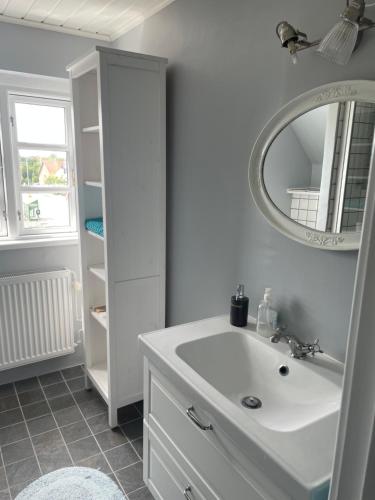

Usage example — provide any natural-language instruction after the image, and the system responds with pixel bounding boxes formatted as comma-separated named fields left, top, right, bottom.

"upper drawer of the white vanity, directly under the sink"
left=149, top=375, right=264, bottom=500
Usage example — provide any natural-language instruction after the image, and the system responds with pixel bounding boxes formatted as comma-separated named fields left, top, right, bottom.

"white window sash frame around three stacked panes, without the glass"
left=8, top=92, right=76, bottom=238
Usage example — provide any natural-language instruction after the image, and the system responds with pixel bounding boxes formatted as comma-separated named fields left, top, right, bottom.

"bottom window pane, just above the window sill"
left=22, top=193, right=70, bottom=229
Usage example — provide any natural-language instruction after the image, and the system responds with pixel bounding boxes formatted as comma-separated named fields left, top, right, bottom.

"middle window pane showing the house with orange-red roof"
left=18, top=149, right=68, bottom=186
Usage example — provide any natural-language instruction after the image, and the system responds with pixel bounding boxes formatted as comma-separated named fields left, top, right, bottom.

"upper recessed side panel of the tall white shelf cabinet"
left=102, top=57, right=165, bottom=282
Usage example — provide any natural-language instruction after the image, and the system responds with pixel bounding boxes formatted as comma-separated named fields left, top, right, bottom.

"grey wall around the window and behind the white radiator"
left=0, top=23, right=102, bottom=383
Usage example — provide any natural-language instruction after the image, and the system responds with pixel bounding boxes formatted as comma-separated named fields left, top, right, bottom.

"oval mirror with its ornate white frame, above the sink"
left=249, top=81, right=375, bottom=250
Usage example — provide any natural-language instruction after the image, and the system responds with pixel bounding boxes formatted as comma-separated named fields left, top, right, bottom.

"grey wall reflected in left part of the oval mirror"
left=264, top=126, right=312, bottom=216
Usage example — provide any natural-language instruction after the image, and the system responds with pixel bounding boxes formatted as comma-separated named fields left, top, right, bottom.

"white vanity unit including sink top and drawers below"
left=140, top=316, right=343, bottom=500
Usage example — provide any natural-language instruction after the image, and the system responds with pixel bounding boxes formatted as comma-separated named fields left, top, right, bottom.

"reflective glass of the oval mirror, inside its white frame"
left=263, top=101, right=375, bottom=233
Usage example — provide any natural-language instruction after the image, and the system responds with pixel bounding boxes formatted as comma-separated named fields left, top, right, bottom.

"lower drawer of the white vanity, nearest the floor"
left=147, top=431, right=212, bottom=500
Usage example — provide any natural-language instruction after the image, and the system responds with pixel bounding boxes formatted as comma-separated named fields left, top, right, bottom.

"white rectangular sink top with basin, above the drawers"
left=140, top=316, right=343, bottom=500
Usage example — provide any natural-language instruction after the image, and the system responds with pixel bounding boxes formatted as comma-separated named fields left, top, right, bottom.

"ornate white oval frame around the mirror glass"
left=249, top=80, right=375, bottom=250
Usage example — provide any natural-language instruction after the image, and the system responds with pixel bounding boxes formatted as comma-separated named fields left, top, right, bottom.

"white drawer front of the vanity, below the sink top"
left=143, top=361, right=280, bottom=500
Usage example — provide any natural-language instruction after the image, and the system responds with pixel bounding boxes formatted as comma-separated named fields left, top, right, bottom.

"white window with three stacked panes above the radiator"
left=0, top=94, right=76, bottom=238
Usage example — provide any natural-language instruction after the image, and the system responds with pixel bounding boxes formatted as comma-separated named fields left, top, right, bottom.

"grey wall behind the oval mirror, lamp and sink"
left=115, top=0, right=375, bottom=359
